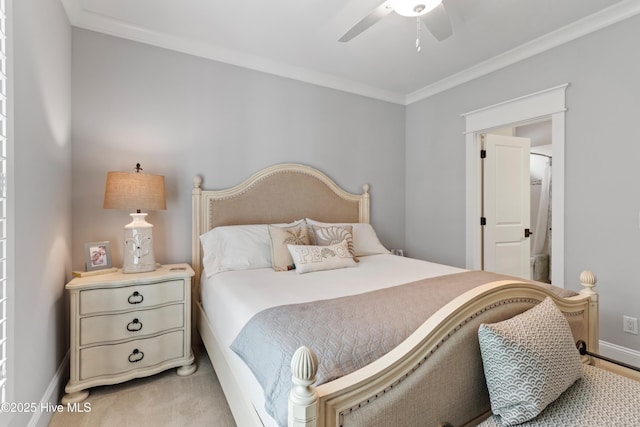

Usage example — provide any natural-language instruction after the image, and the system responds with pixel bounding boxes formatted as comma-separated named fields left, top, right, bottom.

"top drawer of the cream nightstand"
left=80, top=280, right=184, bottom=314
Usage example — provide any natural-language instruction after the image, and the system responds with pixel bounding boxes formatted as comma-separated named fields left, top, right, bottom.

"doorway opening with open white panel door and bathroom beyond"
left=482, top=119, right=553, bottom=283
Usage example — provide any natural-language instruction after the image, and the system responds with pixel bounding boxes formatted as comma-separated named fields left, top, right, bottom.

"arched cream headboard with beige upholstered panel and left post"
left=192, top=163, right=370, bottom=281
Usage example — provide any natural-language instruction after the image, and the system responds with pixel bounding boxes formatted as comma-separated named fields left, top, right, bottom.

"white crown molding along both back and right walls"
left=62, top=0, right=640, bottom=106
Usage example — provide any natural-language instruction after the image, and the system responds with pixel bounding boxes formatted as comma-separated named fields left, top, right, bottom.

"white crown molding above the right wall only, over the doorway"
left=405, top=0, right=640, bottom=105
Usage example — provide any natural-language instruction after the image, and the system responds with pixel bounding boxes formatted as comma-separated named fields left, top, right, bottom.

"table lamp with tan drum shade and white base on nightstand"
left=103, top=163, right=167, bottom=273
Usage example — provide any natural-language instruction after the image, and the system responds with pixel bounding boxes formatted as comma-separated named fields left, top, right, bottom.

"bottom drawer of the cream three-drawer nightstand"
left=80, top=331, right=185, bottom=380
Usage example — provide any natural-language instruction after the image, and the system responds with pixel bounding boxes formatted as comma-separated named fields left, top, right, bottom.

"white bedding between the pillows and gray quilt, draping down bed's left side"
left=200, top=254, right=465, bottom=426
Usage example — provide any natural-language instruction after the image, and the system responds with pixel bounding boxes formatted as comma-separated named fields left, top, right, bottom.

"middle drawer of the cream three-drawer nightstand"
left=80, top=304, right=184, bottom=346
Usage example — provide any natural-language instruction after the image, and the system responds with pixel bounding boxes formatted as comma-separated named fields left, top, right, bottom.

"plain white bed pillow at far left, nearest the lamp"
left=200, top=224, right=271, bottom=277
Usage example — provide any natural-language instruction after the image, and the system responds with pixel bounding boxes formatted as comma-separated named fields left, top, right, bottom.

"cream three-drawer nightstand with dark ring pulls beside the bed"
left=62, top=264, right=196, bottom=404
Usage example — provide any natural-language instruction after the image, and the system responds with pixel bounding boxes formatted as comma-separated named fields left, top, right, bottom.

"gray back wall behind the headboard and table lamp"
left=72, top=28, right=405, bottom=269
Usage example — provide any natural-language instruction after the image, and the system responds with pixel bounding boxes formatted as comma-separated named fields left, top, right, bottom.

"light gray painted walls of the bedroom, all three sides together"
left=16, top=0, right=640, bottom=416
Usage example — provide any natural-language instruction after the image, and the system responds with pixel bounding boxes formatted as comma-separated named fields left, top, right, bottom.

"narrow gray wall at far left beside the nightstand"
left=9, top=0, right=71, bottom=426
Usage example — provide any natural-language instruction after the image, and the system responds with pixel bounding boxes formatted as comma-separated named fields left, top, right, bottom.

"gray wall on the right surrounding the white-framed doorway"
left=406, top=16, right=640, bottom=350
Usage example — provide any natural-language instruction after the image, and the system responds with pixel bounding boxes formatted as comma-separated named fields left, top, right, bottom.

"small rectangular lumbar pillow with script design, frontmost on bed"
left=287, top=240, right=356, bottom=274
